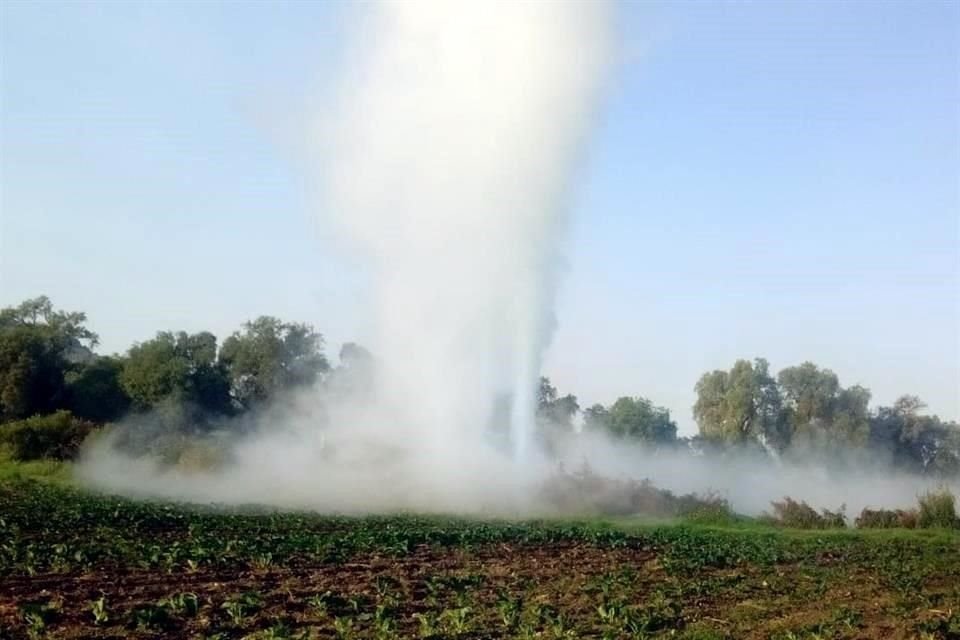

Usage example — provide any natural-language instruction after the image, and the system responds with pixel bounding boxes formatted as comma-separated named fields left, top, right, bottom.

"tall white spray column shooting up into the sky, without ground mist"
left=319, top=1, right=611, bottom=464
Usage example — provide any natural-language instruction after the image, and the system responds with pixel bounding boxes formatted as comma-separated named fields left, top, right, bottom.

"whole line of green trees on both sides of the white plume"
left=0, top=296, right=960, bottom=476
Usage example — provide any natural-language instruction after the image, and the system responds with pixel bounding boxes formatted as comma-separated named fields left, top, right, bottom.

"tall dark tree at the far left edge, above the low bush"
left=0, top=296, right=97, bottom=421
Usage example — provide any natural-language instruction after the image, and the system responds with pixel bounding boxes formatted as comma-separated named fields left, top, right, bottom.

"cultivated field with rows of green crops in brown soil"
left=0, top=480, right=960, bottom=640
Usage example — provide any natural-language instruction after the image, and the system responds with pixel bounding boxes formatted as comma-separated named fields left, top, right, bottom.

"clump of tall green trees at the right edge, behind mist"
left=692, top=358, right=960, bottom=477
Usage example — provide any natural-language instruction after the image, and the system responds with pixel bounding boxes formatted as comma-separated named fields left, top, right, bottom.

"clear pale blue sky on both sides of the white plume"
left=0, top=1, right=960, bottom=433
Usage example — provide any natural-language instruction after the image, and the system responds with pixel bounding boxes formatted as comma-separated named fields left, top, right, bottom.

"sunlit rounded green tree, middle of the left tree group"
left=120, top=331, right=230, bottom=413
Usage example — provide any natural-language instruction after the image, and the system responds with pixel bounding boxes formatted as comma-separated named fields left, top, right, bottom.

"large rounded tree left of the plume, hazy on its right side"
left=220, top=316, right=330, bottom=407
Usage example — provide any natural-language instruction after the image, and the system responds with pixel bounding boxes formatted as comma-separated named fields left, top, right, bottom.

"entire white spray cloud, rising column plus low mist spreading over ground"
left=80, top=0, right=952, bottom=513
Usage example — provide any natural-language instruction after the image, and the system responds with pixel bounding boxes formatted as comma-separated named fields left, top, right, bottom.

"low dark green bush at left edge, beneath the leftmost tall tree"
left=0, top=411, right=97, bottom=461
